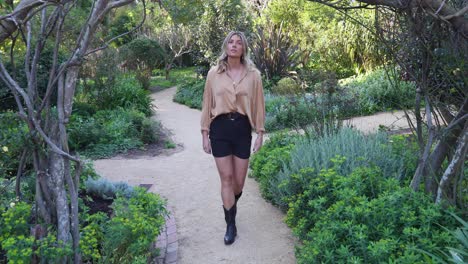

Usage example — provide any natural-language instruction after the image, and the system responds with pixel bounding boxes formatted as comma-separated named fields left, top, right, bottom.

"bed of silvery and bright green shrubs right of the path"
left=251, top=129, right=462, bottom=263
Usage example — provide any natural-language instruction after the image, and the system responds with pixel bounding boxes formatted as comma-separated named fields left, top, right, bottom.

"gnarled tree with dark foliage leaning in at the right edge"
left=306, top=0, right=468, bottom=203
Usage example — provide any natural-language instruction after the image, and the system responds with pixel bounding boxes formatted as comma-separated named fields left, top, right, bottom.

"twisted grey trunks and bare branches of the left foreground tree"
left=0, top=0, right=138, bottom=264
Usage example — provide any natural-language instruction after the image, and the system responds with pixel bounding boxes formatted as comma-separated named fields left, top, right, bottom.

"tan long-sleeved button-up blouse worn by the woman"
left=200, top=66, right=265, bottom=133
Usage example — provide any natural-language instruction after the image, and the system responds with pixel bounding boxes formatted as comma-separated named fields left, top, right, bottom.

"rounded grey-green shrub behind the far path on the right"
left=341, top=69, right=416, bottom=114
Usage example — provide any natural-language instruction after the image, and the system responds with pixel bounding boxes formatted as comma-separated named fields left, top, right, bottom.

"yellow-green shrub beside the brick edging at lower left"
left=102, top=188, right=166, bottom=263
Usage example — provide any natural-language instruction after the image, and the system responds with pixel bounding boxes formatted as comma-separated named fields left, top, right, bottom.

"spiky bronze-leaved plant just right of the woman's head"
left=252, top=23, right=301, bottom=79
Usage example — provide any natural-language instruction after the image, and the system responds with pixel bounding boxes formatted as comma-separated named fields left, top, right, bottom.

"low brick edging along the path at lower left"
left=154, top=208, right=179, bottom=264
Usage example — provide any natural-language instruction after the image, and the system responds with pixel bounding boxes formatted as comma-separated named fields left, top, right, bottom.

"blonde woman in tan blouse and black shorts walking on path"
left=201, top=32, right=265, bottom=245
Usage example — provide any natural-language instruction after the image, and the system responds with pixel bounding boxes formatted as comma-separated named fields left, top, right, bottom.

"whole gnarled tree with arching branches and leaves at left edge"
left=0, top=0, right=139, bottom=263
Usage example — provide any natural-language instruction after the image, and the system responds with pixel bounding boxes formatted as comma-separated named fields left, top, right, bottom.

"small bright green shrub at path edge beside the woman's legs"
left=249, top=133, right=297, bottom=201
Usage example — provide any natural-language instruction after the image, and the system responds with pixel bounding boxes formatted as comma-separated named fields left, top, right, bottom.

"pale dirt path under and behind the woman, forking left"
left=94, top=88, right=295, bottom=264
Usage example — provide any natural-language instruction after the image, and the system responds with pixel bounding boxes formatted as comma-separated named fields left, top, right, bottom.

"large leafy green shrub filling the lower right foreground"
left=286, top=164, right=454, bottom=264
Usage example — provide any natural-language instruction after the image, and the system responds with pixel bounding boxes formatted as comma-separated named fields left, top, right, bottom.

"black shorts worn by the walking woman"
left=210, top=113, right=252, bottom=159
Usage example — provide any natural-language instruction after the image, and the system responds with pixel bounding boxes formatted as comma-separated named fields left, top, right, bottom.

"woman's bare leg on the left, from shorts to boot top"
left=215, top=155, right=234, bottom=209
